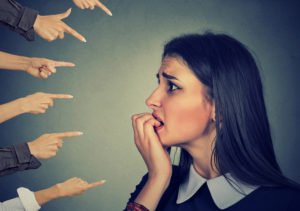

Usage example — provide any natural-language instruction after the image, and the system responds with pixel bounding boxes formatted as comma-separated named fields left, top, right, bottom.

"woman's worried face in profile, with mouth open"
left=146, top=57, right=214, bottom=146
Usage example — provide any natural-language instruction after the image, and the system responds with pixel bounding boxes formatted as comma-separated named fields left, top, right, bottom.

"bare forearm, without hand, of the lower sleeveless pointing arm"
left=0, top=98, right=25, bottom=123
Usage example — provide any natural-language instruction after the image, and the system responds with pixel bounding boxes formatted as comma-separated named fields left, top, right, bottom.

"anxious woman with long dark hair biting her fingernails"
left=126, top=33, right=300, bottom=211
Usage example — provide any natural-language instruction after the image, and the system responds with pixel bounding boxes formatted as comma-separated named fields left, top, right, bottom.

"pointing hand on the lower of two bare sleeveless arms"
left=19, top=92, right=73, bottom=114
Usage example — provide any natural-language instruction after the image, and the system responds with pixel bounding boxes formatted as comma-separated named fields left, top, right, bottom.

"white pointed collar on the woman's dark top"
left=176, top=165, right=258, bottom=210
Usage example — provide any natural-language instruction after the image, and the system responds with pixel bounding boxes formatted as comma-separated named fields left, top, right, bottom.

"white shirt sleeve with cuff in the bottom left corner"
left=0, top=188, right=41, bottom=211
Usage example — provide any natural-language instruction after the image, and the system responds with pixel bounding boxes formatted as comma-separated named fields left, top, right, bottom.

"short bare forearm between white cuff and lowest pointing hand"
left=34, top=185, right=62, bottom=206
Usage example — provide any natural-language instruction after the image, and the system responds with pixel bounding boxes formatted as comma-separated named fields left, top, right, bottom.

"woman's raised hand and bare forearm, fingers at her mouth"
left=132, top=113, right=172, bottom=210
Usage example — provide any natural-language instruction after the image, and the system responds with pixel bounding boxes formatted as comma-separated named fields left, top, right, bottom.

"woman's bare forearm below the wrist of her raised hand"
left=135, top=178, right=169, bottom=211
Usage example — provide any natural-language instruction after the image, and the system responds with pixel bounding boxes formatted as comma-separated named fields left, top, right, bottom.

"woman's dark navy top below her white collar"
left=128, top=168, right=300, bottom=211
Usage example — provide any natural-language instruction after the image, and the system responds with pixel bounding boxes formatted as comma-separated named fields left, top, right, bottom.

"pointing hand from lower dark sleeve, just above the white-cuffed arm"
left=28, top=131, right=82, bottom=159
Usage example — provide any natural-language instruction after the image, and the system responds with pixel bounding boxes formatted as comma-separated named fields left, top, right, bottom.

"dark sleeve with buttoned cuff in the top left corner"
left=0, top=0, right=38, bottom=41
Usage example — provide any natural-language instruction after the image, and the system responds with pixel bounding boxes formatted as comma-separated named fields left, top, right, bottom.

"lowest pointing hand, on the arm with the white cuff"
left=55, top=177, right=106, bottom=197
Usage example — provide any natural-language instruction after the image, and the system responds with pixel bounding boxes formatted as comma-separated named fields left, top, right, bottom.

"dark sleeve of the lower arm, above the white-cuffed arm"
left=0, top=143, right=41, bottom=176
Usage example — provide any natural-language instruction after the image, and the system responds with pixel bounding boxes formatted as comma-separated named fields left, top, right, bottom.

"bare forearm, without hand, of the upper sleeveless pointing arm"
left=0, top=51, right=31, bottom=71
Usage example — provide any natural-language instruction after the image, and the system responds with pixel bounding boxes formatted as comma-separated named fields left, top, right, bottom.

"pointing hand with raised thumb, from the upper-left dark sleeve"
left=33, top=8, right=86, bottom=42
